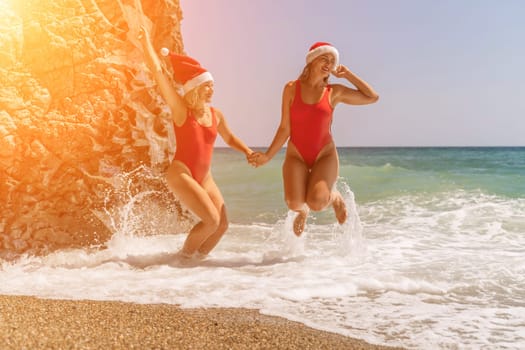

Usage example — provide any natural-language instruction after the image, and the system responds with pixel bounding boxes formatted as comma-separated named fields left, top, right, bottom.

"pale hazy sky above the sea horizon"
left=180, top=0, right=525, bottom=146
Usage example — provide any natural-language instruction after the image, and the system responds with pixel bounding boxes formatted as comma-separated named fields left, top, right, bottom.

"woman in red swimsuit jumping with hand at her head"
left=250, top=42, right=379, bottom=236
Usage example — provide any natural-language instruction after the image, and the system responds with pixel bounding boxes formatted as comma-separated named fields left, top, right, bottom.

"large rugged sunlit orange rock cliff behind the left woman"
left=0, top=0, right=192, bottom=258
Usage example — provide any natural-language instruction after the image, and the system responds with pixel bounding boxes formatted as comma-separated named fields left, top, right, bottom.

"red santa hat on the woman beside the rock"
left=160, top=47, right=213, bottom=94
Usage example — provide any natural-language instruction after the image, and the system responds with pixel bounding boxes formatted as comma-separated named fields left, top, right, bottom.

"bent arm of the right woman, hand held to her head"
left=331, top=65, right=379, bottom=107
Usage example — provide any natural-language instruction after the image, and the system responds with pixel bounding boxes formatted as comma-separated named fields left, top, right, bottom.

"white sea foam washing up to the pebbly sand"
left=0, top=184, right=525, bottom=349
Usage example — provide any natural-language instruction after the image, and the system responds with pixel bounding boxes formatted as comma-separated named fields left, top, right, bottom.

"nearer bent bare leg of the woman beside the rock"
left=167, top=161, right=221, bottom=256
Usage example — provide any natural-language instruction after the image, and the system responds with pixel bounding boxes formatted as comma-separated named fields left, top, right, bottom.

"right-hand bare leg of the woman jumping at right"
left=306, top=147, right=347, bottom=224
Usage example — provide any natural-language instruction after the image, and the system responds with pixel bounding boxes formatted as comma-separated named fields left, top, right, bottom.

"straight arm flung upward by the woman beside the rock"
left=139, top=26, right=186, bottom=125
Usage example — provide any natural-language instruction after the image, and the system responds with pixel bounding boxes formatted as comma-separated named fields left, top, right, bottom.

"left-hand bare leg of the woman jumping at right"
left=283, top=142, right=310, bottom=236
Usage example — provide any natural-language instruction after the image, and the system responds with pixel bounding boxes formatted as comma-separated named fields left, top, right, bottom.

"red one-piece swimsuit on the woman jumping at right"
left=290, top=80, right=333, bottom=168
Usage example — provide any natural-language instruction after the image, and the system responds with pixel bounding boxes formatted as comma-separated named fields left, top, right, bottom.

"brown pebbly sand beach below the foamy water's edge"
left=0, top=296, right=402, bottom=349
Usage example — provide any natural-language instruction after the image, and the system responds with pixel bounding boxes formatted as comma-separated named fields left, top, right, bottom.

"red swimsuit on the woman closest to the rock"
left=173, top=108, right=217, bottom=184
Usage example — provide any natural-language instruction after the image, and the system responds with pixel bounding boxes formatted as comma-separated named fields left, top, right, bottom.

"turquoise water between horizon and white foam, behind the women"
left=213, top=147, right=525, bottom=221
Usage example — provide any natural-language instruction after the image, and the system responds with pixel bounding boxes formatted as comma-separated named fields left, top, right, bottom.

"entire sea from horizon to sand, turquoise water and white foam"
left=0, top=148, right=525, bottom=349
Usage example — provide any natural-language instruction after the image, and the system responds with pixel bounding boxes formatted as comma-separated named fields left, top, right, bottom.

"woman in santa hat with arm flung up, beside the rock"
left=140, top=27, right=252, bottom=257
